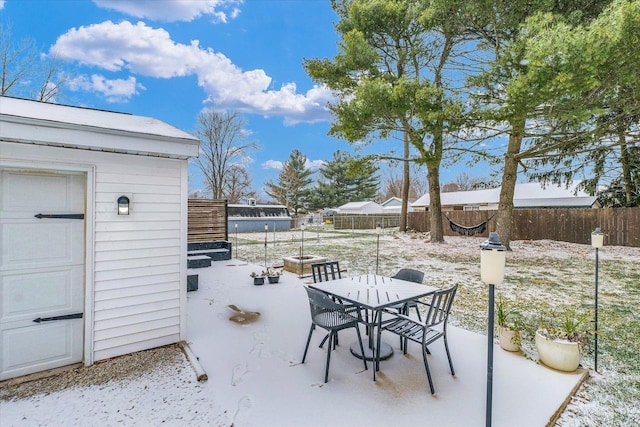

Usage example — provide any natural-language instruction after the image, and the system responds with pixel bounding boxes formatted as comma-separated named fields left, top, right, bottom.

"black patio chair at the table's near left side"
left=302, top=286, right=368, bottom=383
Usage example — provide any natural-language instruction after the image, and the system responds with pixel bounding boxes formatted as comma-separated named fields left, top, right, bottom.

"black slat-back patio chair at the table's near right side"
left=378, top=285, right=458, bottom=394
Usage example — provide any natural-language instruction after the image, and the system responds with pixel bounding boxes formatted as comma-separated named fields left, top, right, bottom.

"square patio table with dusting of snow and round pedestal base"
left=309, top=274, right=438, bottom=381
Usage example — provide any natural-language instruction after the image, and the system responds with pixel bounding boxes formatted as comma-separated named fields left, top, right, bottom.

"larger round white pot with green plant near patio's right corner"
left=535, top=308, right=590, bottom=372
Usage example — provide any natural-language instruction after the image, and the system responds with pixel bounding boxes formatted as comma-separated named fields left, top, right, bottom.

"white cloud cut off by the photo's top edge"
left=93, top=0, right=242, bottom=23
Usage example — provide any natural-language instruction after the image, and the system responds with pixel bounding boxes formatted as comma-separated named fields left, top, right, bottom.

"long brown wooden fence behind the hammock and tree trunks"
left=408, top=208, right=640, bottom=247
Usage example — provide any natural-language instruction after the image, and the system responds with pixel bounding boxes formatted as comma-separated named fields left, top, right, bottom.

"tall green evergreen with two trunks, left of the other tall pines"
left=304, top=0, right=466, bottom=243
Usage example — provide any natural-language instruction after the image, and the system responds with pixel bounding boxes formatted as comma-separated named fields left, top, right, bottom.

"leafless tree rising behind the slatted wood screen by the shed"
left=195, top=110, right=258, bottom=199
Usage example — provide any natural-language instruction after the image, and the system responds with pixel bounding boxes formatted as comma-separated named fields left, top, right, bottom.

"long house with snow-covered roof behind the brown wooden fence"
left=411, top=181, right=599, bottom=211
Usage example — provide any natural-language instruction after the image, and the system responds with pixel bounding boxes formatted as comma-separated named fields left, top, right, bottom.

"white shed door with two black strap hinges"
left=0, top=169, right=86, bottom=380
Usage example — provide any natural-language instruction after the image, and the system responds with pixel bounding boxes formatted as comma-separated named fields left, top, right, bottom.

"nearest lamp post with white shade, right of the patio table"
left=480, top=232, right=507, bottom=427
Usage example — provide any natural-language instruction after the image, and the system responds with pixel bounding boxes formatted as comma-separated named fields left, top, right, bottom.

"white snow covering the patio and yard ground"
left=0, top=235, right=640, bottom=427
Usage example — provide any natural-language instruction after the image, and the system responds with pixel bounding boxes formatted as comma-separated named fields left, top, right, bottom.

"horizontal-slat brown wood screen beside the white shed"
left=187, top=199, right=228, bottom=243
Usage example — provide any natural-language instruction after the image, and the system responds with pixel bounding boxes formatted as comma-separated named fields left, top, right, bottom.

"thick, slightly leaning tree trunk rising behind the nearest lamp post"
left=496, top=119, right=525, bottom=250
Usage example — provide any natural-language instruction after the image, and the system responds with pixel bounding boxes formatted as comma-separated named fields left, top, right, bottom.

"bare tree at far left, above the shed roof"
left=0, top=25, right=69, bottom=102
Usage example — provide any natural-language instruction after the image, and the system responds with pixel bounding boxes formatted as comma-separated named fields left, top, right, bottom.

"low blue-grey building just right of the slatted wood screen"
left=227, top=204, right=291, bottom=233
